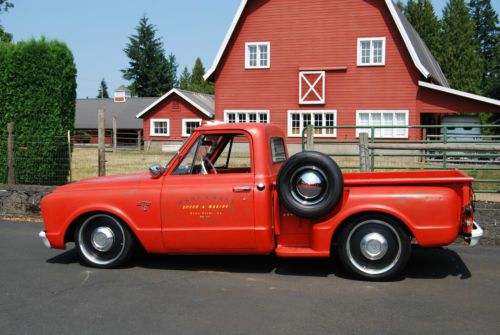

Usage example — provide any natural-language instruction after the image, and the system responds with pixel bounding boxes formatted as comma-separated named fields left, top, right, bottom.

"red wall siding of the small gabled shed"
left=143, top=94, right=209, bottom=141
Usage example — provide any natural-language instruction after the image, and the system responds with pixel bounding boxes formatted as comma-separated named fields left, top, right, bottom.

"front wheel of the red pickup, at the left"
left=75, top=214, right=134, bottom=268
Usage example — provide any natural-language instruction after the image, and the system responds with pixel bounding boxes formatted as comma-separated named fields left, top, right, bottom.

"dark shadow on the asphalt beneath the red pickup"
left=47, top=247, right=472, bottom=281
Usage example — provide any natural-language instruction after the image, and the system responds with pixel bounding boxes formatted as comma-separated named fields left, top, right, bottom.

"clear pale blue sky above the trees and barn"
left=0, top=0, right=500, bottom=98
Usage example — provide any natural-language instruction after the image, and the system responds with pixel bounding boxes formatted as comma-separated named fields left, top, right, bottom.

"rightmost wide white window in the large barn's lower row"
left=356, top=110, right=408, bottom=138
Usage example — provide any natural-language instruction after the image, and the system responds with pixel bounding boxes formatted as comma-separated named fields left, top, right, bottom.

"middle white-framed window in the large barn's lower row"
left=288, top=110, right=337, bottom=137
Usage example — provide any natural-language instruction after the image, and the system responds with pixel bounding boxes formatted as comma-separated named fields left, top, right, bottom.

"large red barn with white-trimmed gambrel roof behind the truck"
left=204, top=0, right=500, bottom=143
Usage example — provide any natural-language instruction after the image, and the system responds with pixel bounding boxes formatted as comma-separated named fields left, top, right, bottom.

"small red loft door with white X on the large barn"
left=299, top=71, right=325, bottom=105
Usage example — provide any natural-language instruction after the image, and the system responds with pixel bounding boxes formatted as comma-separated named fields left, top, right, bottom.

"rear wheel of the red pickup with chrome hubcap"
left=338, top=215, right=411, bottom=280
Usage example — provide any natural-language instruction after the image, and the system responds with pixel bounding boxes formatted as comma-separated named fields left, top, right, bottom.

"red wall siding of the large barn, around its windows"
left=214, top=0, right=434, bottom=142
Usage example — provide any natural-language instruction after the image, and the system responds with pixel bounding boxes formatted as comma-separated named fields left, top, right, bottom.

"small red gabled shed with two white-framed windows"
left=136, top=88, right=214, bottom=148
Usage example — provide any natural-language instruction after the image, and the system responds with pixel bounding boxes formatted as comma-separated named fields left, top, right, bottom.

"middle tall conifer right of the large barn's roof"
left=438, top=0, right=482, bottom=93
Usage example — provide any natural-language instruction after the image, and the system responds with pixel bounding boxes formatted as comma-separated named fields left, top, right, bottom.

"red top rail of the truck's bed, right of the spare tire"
left=344, top=170, right=474, bottom=186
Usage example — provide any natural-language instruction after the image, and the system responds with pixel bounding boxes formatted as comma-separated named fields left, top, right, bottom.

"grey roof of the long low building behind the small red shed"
left=75, top=97, right=154, bottom=129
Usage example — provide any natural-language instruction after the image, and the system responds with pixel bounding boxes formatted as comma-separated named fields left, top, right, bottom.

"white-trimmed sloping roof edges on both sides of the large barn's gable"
left=205, top=0, right=449, bottom=87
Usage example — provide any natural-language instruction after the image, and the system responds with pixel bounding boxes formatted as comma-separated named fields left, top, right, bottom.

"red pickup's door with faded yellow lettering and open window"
left=161, top=133, right=256, bottom=253
